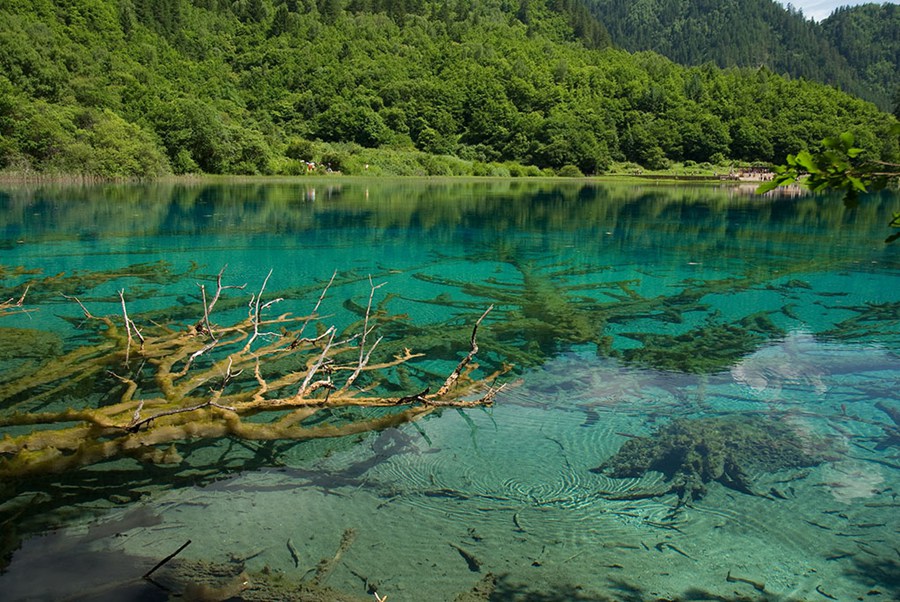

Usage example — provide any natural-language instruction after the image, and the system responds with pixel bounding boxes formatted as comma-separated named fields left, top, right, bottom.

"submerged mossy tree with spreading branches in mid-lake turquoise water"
left=400, top=245, right=883, bottom=374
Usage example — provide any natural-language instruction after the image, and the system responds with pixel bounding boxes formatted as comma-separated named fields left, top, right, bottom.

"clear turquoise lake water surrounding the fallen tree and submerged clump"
left=0, top=180, right=900, bottom=600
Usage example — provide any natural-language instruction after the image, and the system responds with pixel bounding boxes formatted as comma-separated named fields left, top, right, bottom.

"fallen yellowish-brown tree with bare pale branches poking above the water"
left=0, top=270, right=505, bottom=479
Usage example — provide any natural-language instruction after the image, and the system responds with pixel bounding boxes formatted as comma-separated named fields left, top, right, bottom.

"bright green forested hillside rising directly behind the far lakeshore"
left=0, top=0, right=898, bottom=177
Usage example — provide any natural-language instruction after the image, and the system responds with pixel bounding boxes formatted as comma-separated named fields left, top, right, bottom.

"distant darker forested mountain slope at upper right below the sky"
left=587, top=0, right=900, bottom=110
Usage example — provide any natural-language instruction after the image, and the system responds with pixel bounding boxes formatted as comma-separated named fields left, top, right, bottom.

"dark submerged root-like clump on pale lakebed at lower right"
left=592, top=415, right=826, bottom=507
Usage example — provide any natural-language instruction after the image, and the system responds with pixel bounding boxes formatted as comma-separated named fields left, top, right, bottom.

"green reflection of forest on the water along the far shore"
left=0, top=179, right=897, bottom=252
